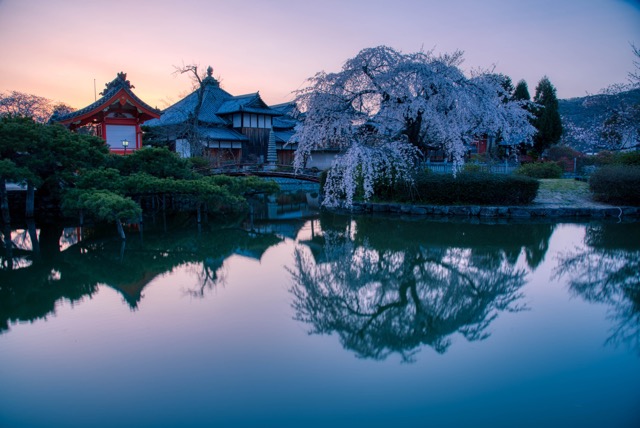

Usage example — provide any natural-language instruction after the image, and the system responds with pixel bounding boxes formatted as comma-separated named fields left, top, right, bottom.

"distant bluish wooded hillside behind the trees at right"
left=558, top=89, right=640, bottom=152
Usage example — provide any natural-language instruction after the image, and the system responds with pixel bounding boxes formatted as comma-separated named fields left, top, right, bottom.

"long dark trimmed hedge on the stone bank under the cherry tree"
left=394, top=172, right=540, bottom=205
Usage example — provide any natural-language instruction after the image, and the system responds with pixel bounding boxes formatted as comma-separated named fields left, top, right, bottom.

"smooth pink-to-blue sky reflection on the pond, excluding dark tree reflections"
left=0, top=223, right=640, bottom=427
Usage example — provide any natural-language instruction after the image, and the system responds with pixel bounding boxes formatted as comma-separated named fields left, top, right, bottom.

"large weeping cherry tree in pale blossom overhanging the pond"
left=292, top=46, right=535, bottom=206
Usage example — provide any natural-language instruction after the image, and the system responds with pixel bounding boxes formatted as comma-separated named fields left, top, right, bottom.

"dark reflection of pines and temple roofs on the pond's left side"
left=0, top=221, right=282, bottom=333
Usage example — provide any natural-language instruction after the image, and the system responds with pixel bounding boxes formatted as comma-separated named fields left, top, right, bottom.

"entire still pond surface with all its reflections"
left=0, top=213, right=640, bottom=428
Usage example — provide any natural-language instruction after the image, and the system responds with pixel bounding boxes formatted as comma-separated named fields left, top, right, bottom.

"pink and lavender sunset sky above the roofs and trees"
left=0, top=0, right=640, bottom=108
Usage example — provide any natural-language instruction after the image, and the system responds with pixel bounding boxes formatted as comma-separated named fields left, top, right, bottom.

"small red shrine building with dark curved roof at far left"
left=51, top=73, right=160, bottom=153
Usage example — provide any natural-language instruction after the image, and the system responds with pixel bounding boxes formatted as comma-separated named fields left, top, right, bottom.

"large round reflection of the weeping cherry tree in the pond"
left=291, top=217, right=525, bottom=361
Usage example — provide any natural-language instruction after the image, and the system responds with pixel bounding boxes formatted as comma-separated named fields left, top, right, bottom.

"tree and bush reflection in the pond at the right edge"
left=555, top=224, right=640, bottom=354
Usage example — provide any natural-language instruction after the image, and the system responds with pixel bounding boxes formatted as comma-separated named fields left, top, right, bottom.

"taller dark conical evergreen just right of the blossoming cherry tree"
left=533, top=76, right=562, bottom=154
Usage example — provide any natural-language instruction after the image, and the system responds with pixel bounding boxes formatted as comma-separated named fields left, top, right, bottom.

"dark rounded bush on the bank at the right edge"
left=589, top=165, right=640, bottom=205
